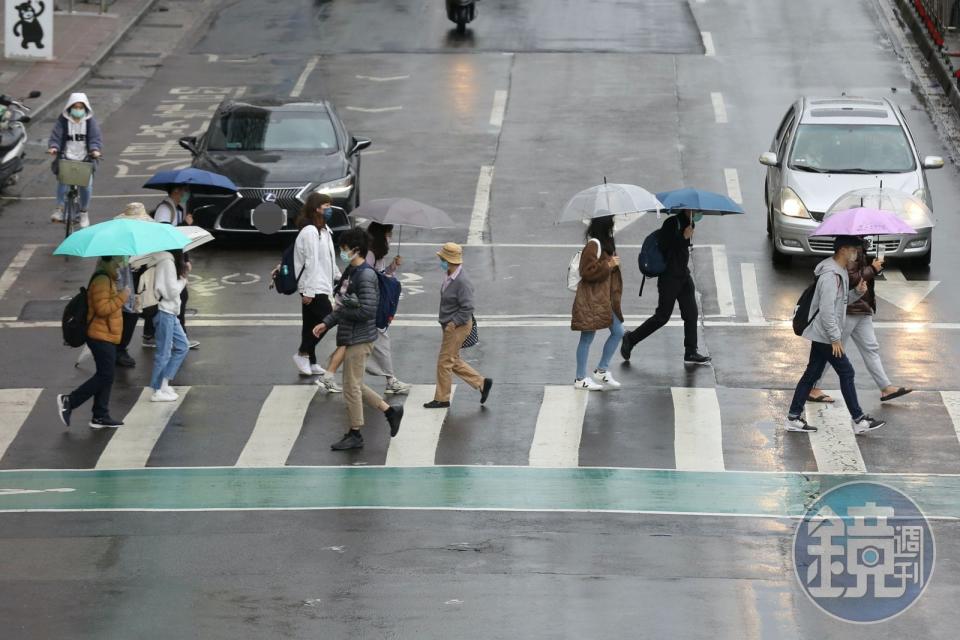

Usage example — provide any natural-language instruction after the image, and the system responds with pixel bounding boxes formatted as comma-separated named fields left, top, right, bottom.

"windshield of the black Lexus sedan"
left=207, top=108, right=337, bottom=153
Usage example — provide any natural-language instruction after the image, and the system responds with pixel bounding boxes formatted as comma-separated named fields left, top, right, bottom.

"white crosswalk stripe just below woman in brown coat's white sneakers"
left=529, top=385, right=591, bottom=468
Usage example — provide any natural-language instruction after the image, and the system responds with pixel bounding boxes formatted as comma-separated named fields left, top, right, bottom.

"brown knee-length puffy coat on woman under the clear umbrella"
left=570, top=240, right=623, bottom=331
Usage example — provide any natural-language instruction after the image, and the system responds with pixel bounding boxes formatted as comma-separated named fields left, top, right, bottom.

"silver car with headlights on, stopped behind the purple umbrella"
left=760, top=96, right=943, bottom=264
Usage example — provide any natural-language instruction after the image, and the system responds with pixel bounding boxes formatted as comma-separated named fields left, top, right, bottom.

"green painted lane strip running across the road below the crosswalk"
left=0, top=466, right=960, bottom=518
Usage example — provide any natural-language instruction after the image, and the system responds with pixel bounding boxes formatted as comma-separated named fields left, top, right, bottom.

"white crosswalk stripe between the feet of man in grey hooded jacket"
left=808, top=390, right=867, bottom=473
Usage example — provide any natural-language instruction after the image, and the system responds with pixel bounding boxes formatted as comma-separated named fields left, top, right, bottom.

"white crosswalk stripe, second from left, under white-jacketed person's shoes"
left=96, top=387, right=190, bottom=469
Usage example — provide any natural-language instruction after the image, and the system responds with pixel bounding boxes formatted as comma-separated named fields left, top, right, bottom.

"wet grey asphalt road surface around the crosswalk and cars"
left=0, top=0, right=960, bottom=638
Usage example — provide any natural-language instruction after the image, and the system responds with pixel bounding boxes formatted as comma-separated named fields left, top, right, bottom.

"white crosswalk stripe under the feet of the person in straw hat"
left=384, top=384, right=457, bottom=467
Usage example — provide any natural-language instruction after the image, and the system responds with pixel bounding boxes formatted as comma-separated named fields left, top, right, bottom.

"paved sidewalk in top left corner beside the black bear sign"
left=0, top=0, right=156, bottom=118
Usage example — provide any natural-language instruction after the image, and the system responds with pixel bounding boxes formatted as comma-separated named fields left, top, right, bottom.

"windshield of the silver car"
left=790, top=124, right=916, bottom=173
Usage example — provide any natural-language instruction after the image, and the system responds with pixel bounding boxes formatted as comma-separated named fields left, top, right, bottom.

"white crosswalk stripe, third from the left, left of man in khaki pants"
left=235, top=384, right=320, bottom=467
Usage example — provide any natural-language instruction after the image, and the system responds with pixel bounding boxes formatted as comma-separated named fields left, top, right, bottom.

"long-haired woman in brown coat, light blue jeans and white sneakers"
left=570, top=216, right=623, bottom=391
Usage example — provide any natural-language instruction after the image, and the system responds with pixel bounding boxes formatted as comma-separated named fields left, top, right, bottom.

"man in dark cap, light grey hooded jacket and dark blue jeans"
left=786, top=236, right=886, bottom=435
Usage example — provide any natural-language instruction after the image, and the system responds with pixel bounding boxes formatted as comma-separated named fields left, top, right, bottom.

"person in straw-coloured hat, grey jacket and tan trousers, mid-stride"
left=423, top=242, right=493, bottom=409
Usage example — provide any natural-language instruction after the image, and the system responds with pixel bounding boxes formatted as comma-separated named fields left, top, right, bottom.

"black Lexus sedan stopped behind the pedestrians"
left=180, top=99, right=370, bottom=232
